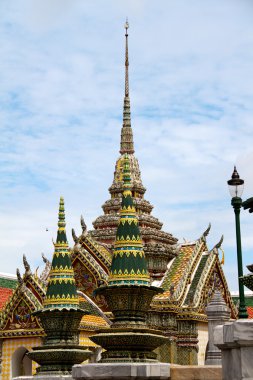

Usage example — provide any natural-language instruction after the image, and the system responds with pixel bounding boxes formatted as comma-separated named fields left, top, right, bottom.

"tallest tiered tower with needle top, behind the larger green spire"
left=90, top=23, right=178, bottom=280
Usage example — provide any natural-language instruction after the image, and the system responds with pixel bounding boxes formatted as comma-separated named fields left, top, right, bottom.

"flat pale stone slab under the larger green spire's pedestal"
left=72, top=363, right=170, bottom=380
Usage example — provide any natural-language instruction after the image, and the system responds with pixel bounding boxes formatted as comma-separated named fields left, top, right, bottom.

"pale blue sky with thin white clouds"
left=0, top=0, right=253, bottom=290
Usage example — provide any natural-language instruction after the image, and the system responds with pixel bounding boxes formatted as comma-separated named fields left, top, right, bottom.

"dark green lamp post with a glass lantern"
left=227, top=167, right=248, bottom=318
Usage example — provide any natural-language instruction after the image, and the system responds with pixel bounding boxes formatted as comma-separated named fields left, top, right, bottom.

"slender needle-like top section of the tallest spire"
left=120, top=20, right=134, bottom=154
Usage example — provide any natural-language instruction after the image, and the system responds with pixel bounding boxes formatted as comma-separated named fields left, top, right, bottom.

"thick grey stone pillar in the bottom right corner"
left=214, top=319, right=253, bottom=380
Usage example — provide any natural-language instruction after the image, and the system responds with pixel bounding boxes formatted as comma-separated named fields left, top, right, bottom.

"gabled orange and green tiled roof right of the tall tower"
left=152, top=227, right=237, bottom=320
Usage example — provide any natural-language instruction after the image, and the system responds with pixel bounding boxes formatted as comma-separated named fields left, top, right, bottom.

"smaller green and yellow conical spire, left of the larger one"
left=43, top=197, right=79, bottom=310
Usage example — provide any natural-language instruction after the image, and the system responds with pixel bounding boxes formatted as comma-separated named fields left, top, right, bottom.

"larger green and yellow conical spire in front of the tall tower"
left=108, top=154, right=150, bottom=286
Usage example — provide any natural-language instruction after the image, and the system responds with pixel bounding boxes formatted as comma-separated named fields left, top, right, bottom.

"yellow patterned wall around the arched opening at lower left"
left=1, top=338, right=41, bottom=380
